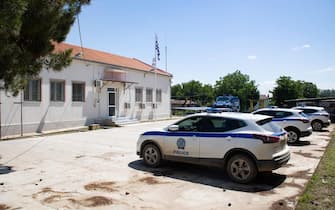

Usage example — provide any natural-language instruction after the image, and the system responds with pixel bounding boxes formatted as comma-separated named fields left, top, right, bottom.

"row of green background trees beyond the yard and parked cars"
left=171, top=70, right=335, bottom=112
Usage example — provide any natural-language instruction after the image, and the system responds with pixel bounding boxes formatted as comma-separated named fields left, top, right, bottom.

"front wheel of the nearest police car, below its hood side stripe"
left=142, top=144, right=161, bottom=167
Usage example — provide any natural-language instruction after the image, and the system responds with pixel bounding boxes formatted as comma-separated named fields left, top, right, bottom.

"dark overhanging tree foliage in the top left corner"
left=0, top=0, right=90, bottom=95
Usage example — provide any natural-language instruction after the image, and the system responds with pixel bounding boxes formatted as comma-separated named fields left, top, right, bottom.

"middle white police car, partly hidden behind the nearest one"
left=253, top=108, right=312, bottom=143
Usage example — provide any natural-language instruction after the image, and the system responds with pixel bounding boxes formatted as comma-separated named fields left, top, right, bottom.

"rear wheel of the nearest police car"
left=227, top=154, right=257, bottom=184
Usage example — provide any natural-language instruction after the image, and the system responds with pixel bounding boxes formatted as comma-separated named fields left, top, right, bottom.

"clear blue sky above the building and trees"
left=66, top=0, right=335, bottom=94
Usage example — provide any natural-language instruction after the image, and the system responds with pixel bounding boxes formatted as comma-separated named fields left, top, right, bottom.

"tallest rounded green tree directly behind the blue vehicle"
left=214, top=70, right=259, bottom=111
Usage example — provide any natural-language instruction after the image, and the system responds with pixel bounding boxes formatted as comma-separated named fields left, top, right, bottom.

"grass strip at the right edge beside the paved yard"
left=296, top=131, right=335, bottom=210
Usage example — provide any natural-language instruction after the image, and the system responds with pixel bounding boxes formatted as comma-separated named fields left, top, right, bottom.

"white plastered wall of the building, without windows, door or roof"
left=0, top=60, right=171, bottom=136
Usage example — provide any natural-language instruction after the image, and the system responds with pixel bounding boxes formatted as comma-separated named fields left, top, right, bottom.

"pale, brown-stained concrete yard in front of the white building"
left=0, top=121, right=334, bottom=210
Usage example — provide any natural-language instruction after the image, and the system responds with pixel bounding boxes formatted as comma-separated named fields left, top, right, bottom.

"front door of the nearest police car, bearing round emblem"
left=164, top=116, right=201, bottom=158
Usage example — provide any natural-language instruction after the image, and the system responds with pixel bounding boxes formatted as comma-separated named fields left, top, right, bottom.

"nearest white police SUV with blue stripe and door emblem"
left=137, top=112, right=290, bottom=183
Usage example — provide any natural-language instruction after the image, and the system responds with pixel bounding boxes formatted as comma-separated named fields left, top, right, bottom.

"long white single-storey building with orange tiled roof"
left=0, top=43, right=172, bottom=136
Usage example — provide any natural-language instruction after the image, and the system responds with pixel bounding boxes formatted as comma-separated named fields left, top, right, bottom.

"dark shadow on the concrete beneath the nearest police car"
left=128, top=160, right=286, bottom=192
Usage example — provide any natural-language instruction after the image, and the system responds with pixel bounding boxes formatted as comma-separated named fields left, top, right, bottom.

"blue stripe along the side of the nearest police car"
left=142, top=131, right=285, bottom=139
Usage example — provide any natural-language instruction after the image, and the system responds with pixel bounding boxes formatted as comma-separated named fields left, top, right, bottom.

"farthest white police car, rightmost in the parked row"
left=292, top=106, right=330, bottom=131
